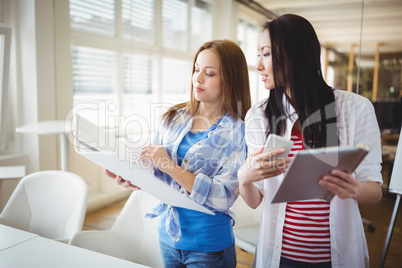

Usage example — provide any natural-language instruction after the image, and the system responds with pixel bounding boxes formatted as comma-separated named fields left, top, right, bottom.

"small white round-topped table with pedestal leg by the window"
left=15, top=120, right=71, bottom=171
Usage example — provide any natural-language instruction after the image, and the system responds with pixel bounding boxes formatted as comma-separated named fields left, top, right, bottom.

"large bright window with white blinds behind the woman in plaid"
left=70, top=0, right=213, bottom=121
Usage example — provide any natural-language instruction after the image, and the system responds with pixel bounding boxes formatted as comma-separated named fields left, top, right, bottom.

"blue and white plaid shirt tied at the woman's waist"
left=147, top=114, right=247, bottom=241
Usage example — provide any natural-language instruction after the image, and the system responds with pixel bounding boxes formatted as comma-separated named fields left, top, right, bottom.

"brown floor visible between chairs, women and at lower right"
left=84, top=188, right=402, bottom=268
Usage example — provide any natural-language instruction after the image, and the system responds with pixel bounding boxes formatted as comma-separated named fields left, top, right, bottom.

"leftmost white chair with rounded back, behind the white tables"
left=0, top=170, right=88, bottom=242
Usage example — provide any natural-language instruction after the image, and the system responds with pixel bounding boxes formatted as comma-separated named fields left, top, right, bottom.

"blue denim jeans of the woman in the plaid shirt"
left=159, top=242, right=237, bottom=268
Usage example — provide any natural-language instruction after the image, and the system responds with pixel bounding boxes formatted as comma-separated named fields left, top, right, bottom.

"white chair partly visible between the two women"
left=232, top=196, right=262, bottom=254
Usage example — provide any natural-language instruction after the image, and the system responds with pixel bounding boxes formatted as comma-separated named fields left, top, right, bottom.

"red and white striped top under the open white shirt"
left=282, top=128, right=331, bottom=263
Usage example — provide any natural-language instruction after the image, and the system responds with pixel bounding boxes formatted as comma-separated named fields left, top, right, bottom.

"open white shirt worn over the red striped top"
left=245, top=90, right=382, bottom=268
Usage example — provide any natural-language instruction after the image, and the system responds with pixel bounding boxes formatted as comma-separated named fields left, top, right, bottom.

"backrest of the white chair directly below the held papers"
left=112, top=191, right=163, bottom=267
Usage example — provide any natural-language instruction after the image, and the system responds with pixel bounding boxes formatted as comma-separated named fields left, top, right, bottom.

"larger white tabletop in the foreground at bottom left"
left=0, top=225, right=147, bottom=268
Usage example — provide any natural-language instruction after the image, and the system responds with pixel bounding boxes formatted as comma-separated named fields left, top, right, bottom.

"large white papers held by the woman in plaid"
left=74, top=115, right=214, bottom=215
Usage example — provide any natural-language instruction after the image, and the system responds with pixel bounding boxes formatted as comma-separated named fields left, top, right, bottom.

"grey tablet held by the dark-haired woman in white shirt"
left=271, top=146, right=368, bottom=203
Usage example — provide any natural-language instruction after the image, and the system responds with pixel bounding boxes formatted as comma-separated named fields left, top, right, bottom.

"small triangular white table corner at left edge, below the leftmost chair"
left=0, top=224, right=38, bottom=251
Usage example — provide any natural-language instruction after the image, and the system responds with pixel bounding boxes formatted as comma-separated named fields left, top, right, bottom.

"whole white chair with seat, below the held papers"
left=70, top=191, right=163, bottom=267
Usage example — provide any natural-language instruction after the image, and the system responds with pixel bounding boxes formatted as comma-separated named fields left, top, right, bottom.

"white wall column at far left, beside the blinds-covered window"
left=0, top=0, right=39, bottom=172
